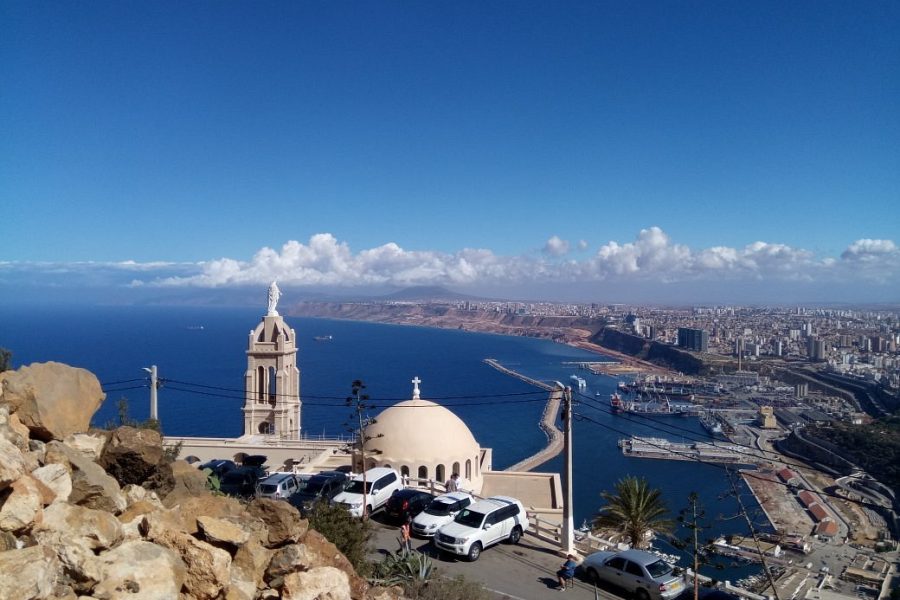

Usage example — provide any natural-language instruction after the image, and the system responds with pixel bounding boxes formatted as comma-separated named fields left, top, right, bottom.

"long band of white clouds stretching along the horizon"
left=0, top=226, right=900, bottom=300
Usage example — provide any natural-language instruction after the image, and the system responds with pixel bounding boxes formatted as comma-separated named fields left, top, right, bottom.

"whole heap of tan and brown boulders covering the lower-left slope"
left=0, top=365, right=401, bottom=600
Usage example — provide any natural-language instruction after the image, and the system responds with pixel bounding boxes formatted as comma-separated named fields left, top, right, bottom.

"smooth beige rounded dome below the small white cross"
left=366, top=398, right=479, bottom=465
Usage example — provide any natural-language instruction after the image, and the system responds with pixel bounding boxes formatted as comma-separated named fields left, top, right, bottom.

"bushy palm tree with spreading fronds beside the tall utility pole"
left=592, top=477, right=672, bottom=548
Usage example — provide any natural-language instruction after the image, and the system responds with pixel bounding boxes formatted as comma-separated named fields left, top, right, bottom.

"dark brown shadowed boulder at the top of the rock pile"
left=98, top=427, right=162, bottom=485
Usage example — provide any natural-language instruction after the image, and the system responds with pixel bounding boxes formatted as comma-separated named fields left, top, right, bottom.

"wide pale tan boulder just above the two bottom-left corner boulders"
left=34, top=502, right=122, bottom=550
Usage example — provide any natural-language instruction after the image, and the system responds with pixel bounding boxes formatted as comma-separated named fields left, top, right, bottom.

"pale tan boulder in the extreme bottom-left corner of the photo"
left=0, top=546, right=60, bottom=600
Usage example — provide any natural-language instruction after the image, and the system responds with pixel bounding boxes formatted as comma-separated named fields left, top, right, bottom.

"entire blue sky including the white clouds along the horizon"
left=0, top=1, right=900, bottom=302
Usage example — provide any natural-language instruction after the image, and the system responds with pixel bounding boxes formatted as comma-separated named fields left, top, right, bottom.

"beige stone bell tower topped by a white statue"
left=243, top=281, right=301, bottom=440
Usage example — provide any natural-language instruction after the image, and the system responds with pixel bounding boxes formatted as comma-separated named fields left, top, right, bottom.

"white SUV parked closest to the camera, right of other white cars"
left=434, top=496, right=528, bottom=561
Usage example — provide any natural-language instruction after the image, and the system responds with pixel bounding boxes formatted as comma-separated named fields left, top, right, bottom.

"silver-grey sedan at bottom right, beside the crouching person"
left=581, top=550, right=684, bottom=600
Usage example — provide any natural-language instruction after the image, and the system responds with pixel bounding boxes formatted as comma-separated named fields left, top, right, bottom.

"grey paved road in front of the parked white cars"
left=372, top=514, right=622, bottom=600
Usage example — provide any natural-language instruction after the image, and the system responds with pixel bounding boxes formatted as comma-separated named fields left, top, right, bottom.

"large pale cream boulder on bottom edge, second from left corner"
left=91, top=541, right=186, bottom=600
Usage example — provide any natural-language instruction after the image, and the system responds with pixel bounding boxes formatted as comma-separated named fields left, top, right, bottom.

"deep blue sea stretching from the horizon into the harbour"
left=0, top=306, right=767, bottom=580
